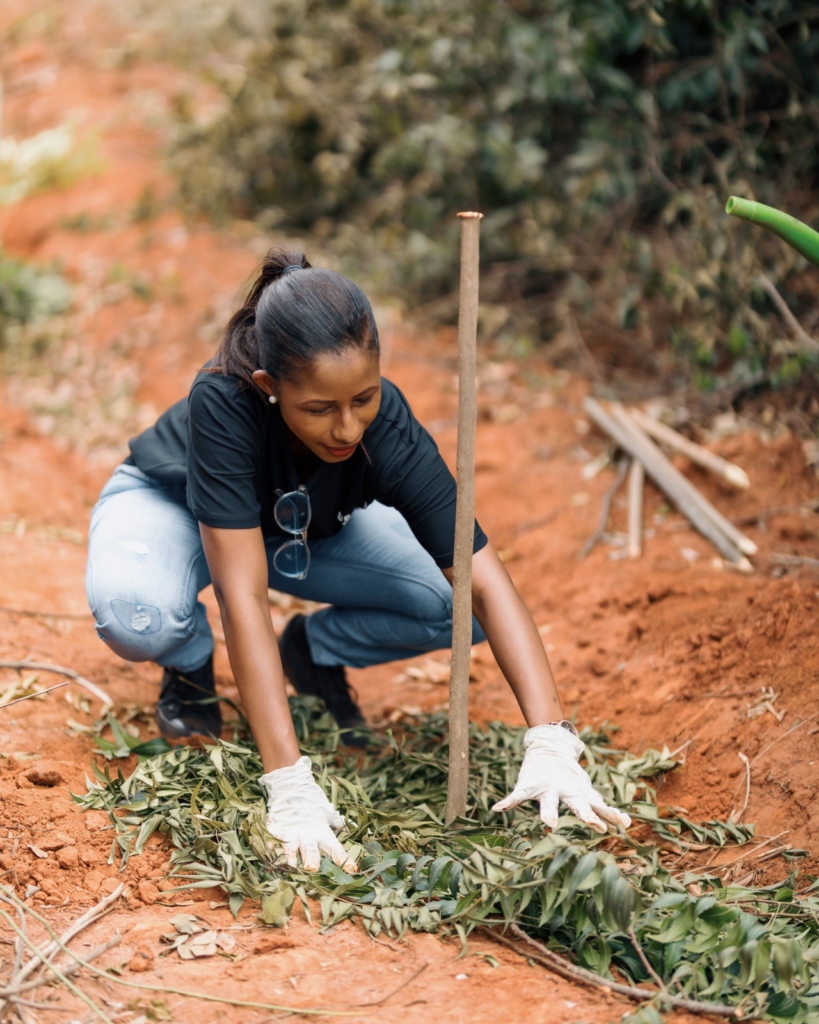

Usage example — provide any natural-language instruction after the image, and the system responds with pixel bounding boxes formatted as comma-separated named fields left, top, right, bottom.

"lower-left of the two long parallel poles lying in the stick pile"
left=584, top=398, right=751, bottom=570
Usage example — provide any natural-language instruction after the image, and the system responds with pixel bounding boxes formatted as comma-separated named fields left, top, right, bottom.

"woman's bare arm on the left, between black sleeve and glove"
left=200, top=524, right=299, bottom=772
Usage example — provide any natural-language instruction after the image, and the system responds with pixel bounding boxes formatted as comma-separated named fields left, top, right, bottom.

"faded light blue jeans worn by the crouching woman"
left=85, top=466, right=484, bottom=672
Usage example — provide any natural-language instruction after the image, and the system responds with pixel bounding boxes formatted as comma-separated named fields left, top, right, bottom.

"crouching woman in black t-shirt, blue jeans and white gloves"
left=87, top=250, right=631, bottom=870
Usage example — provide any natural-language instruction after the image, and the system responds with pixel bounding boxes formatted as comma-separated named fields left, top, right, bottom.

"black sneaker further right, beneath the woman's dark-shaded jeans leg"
left=278, top=615, right=369, bottom=746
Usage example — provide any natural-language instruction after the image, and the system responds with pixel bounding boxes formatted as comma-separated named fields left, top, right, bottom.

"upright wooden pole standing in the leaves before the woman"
left=445, top=213, right=483, bottom=821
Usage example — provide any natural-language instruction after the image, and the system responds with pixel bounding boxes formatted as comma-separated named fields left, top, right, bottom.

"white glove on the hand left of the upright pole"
left=259, top=757, right=358, bottom=872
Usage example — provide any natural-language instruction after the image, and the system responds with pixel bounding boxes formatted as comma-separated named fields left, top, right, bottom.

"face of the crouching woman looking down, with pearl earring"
left=253, top=348, right=381, bottom=462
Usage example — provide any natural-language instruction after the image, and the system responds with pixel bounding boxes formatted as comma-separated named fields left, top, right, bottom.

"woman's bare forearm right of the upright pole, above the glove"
left=443, top=544, right=563, bottom=728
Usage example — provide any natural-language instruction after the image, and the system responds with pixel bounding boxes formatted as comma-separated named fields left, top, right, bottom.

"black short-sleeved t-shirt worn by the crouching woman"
left=129, top=371, right=486, bottom=568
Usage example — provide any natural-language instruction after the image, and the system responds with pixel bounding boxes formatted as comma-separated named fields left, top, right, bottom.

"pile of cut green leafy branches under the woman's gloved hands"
left=78, top=698, right=819, bottom=1022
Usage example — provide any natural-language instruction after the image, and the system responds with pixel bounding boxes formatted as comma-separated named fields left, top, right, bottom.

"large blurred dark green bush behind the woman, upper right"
left=162, top=0, right=819, bottom=383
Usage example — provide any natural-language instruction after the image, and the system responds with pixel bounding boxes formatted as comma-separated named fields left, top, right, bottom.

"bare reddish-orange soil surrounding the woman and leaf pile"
left=0, top=0, right=819, bottom=1024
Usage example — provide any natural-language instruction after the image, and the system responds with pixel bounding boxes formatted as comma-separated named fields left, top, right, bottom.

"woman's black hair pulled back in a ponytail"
left=212, top=249, right=379, bottom=386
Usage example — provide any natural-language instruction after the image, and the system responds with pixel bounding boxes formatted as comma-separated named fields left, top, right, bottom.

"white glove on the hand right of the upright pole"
left=492, top=725, right=632, bottom=833
